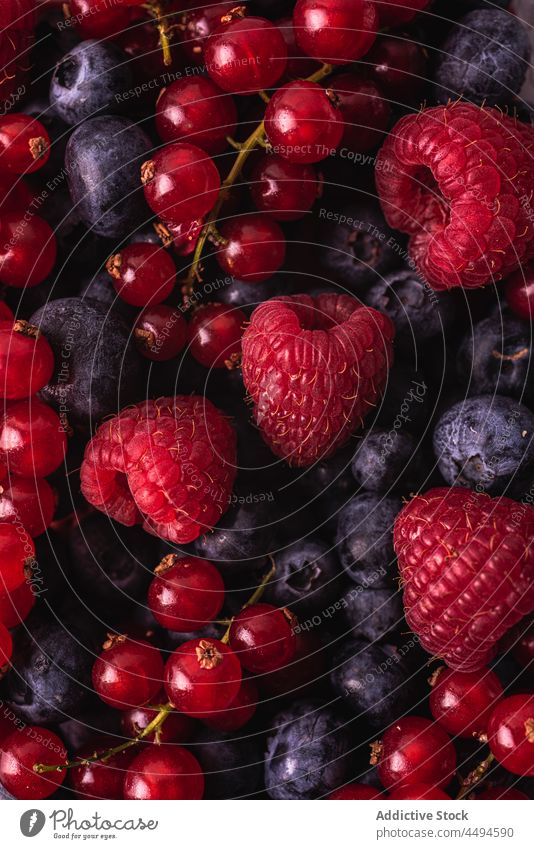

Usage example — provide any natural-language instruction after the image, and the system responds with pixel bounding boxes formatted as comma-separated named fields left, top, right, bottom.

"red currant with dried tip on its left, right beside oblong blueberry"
left=141, top=142, right=221, bottom=223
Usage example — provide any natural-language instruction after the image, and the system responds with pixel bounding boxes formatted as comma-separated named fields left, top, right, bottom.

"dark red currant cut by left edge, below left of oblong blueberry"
left=0, top=212, right=57, bottom=289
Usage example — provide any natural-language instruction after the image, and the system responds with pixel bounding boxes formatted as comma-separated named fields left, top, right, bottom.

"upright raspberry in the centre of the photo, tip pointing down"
left=242, top=294, right=395, bottom=466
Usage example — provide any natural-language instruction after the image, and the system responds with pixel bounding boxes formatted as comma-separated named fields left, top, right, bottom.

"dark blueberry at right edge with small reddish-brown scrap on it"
left=457, top=315, right=534, bottom=399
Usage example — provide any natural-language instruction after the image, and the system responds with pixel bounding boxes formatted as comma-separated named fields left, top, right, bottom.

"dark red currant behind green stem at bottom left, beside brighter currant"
left=69, top=737, right=137, bottom=799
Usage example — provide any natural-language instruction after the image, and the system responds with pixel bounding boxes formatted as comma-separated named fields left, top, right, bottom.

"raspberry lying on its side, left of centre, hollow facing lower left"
left=81, top=395, right=236, bottom=543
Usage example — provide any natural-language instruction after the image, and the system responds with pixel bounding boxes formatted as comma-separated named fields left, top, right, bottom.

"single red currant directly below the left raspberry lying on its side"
left=148, top=554, right=224, bottom=633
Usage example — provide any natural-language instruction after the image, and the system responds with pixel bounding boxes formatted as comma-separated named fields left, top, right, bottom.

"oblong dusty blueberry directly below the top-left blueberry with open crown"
left=65, top=115, right=151, bottom=239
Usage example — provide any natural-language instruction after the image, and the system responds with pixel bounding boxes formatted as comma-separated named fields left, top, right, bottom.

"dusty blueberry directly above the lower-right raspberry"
left=434, top=395, right=534, bottom=494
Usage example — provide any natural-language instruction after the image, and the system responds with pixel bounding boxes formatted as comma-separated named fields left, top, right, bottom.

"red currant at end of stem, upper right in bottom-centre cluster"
left=230, top=604, right=297, bottom=673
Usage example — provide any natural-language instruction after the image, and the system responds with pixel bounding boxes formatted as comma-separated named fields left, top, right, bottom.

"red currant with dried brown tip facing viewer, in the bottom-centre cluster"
left=165, top=637, right=242, bottom=718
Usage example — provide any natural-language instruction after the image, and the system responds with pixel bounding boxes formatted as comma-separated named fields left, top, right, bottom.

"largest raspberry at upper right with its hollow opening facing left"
left=376, top=103, right=534, bottom=290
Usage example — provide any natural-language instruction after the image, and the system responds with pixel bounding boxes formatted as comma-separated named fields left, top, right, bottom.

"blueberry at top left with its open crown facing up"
left=50, top=39, right=132, bottom=126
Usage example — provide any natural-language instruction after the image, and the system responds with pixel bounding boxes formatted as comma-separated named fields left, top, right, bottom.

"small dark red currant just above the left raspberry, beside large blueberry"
left=134, top=304, right=187, bottom=362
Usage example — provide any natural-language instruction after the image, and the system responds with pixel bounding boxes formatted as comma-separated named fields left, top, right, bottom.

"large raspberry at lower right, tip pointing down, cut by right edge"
left=394, top=487, right=534, bottom=672
